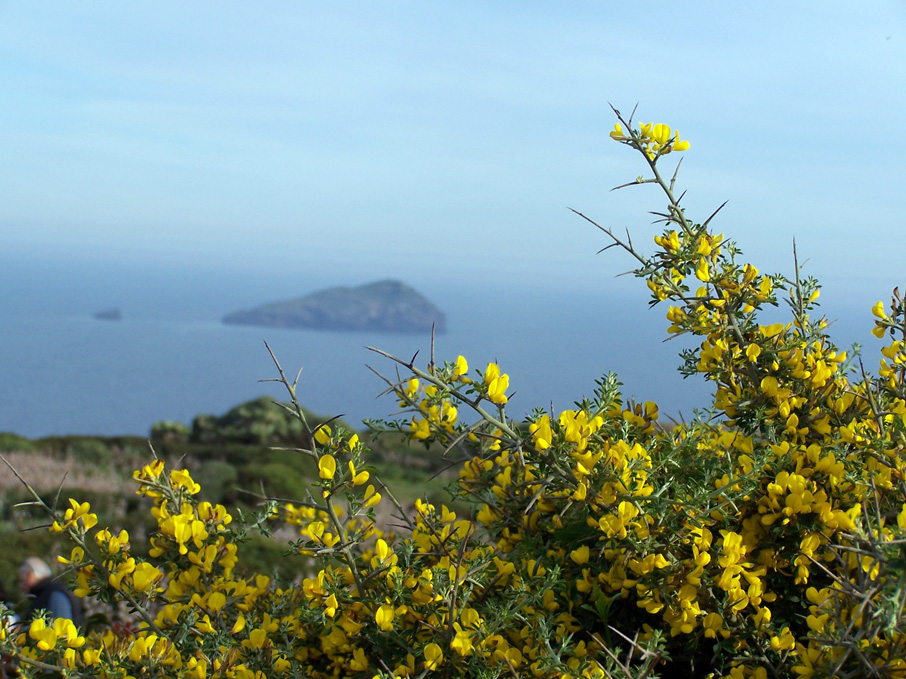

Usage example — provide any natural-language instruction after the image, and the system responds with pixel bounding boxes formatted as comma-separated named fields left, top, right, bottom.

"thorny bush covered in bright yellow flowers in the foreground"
left=2, top=113, right=906, bottom=679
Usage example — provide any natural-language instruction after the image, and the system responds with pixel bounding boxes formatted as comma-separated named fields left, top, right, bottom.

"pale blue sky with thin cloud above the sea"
left=0, top=0, right=906, bottom=306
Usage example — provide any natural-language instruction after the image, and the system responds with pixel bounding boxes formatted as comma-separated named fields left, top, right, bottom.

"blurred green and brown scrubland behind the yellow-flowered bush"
left=0, top=396, right=455, bottom=604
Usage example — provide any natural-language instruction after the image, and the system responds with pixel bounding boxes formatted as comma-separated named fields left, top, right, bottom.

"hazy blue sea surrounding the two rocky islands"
left=0, top=244, right=877, bottom=438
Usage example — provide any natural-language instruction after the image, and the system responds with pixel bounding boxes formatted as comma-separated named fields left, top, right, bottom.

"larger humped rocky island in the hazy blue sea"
left=223, top=280, right=446, bottom=334
